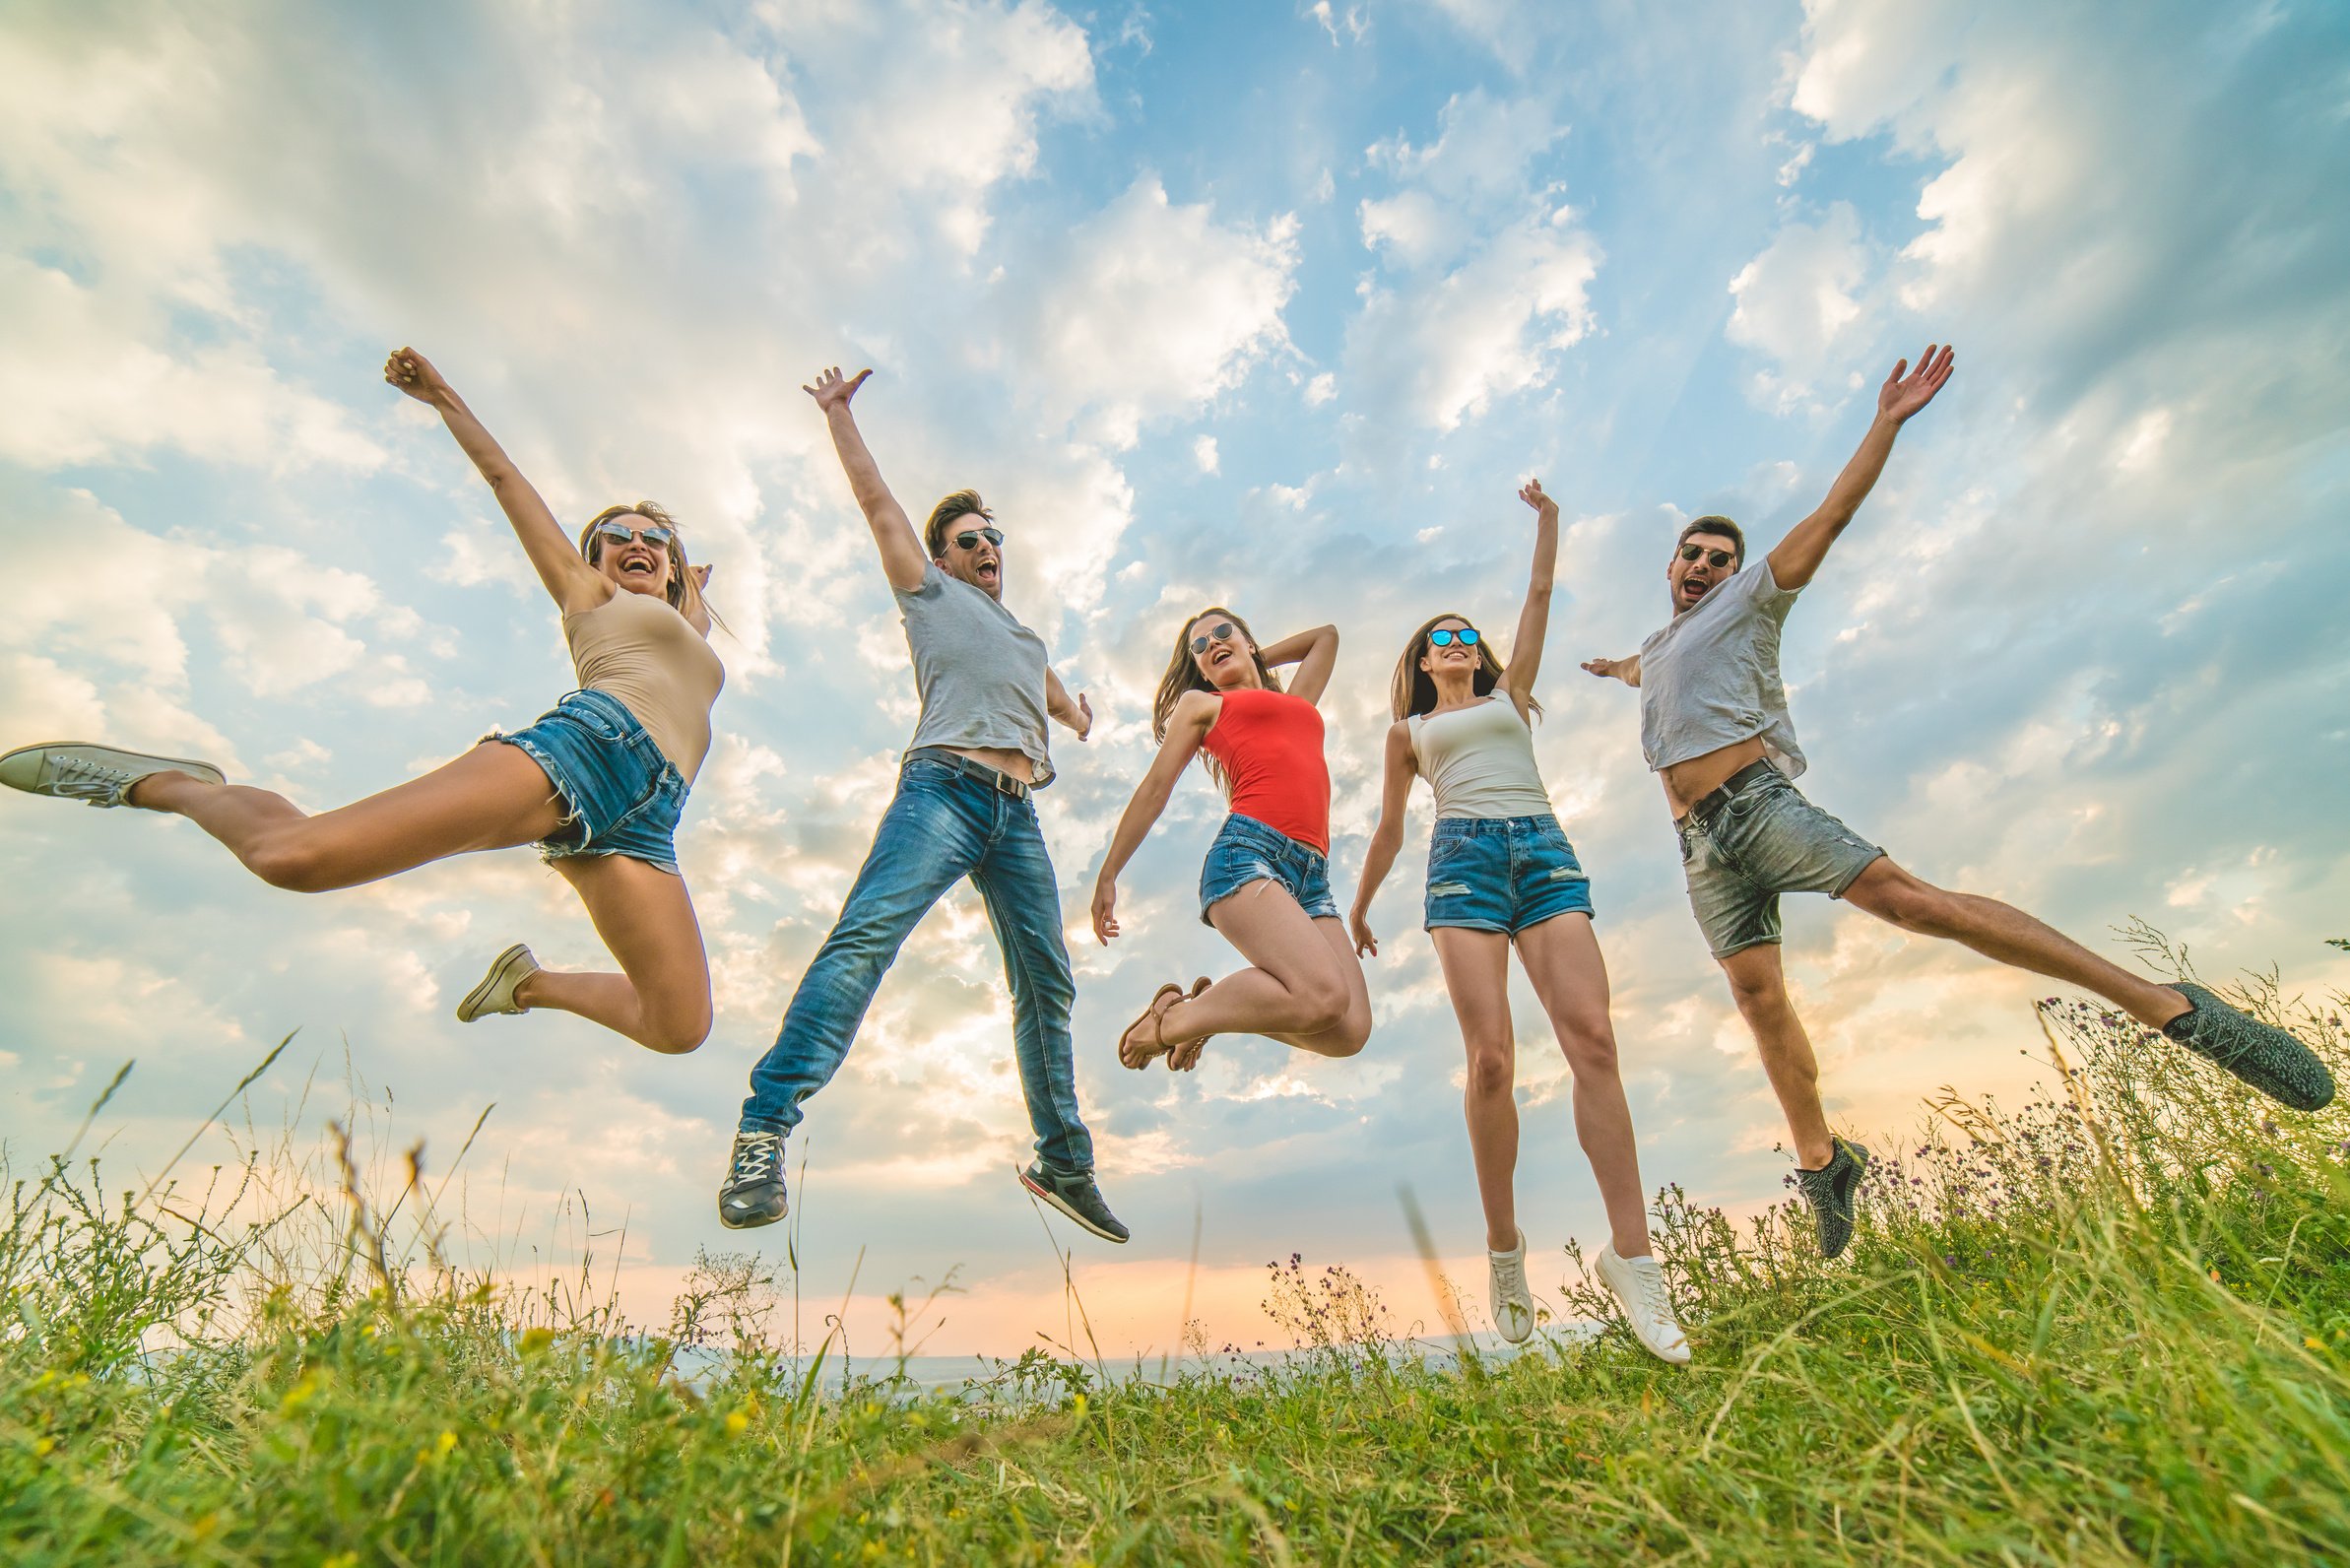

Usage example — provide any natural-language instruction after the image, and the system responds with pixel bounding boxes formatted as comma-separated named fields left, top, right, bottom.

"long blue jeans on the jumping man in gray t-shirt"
left=743, top=757, right=1092, bottom=1171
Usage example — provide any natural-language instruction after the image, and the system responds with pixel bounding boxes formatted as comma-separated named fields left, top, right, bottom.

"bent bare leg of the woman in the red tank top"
left=1161, top=880, right=1370, bottom=1070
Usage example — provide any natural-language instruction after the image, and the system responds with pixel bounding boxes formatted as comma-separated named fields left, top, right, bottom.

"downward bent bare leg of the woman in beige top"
left=515, top=856, right=710, bottom=1056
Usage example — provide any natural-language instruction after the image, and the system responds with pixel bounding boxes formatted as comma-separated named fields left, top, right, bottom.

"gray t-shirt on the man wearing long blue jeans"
left=893, top=561, right=1053, bottom=788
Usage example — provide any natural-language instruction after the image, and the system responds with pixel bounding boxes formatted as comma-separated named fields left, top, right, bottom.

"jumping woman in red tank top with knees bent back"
left=1092, top=607, right=1370, bottom=1072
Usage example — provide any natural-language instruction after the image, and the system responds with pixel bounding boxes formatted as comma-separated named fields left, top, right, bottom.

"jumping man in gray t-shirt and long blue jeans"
left=719, top=369, right=1126, bottom=1241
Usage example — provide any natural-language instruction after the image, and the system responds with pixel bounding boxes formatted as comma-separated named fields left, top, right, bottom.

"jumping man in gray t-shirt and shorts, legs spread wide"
left=1584, top=346, right=2333, bottom=1258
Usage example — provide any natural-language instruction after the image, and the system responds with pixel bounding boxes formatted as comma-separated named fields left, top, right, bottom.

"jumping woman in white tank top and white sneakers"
left=1349, top=480, right=1690, bottom=1363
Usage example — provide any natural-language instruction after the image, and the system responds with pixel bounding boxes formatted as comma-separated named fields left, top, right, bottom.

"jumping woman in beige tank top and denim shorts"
left=0, top=348, right=724, bottom=1053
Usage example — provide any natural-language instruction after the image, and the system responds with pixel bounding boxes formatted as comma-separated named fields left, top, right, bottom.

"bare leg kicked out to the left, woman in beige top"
left=129, top=743, right=564, bottom=893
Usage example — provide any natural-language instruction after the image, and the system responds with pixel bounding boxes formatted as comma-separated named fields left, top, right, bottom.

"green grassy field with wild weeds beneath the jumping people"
left=0, top=926, right=2350, bottom=1566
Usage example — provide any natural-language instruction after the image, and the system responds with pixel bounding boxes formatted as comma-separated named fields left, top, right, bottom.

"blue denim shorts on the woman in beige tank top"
left=482, top=691, right=686, bottom=875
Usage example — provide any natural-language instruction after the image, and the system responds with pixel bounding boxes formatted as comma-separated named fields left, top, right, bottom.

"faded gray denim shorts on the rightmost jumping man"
left=1680, top=768, right=1885, bottom=959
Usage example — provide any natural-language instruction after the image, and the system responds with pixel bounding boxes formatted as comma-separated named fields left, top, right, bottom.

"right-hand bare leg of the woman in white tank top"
left=1518, top=914, right=1650, bottom=1258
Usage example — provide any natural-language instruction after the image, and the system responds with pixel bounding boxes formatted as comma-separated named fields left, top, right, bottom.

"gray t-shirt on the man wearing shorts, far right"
left=1640, top=557, right=1804, bottom=778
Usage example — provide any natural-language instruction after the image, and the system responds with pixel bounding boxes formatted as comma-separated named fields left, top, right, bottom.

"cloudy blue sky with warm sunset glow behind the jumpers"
left=0, top=0, right=2350, bottom=1354
